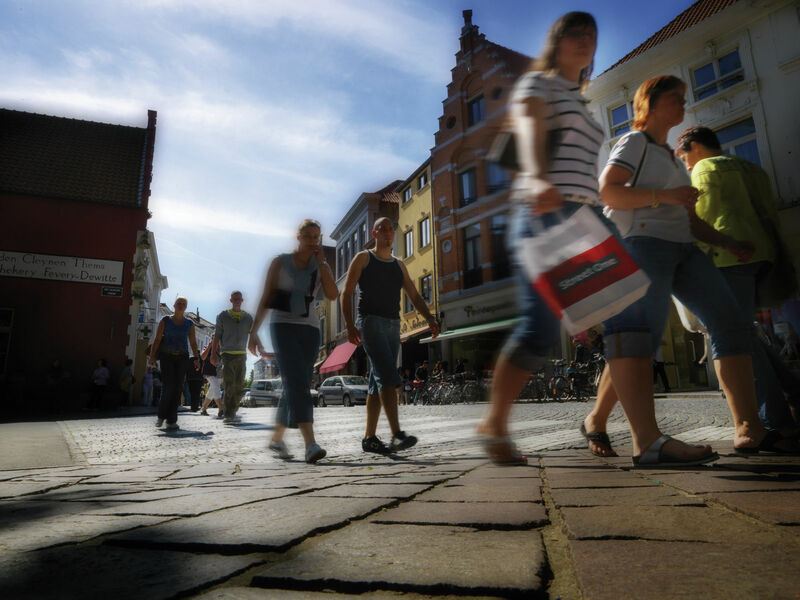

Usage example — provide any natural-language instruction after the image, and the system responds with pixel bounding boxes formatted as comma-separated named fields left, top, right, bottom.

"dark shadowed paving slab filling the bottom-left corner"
left=0, top=546, right=262, bottom=600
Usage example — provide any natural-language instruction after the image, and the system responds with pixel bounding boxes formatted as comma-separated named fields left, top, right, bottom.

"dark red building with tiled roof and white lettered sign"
left=0, top=109, right=156, bottom=409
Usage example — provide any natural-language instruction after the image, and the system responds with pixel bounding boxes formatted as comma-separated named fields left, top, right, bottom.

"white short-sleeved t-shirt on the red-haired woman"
left=604, top=131, right=695, bottom=243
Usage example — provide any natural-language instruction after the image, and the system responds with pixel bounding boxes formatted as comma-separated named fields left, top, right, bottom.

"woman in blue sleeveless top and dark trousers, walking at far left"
left=149, top=296, right=200, bottom=430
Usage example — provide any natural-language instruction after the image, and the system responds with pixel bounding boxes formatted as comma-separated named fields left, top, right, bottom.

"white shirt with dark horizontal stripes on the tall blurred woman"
left=511, top=71, right=604, bottom=204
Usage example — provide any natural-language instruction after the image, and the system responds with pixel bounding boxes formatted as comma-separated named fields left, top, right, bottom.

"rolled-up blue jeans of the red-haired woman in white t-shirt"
left=603, top=236, right=752, bottom=359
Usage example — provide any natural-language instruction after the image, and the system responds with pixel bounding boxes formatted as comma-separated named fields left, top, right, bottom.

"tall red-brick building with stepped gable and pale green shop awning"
left=422, top=10, right=532, bottom=368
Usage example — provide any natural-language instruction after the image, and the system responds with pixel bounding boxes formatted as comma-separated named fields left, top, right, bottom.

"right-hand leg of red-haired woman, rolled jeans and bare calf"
left=675, top=248, right=766, bottom=448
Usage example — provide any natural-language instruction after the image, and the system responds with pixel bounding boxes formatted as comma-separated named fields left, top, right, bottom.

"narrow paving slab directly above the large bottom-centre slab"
left=370, top=500, right=547, bottom=529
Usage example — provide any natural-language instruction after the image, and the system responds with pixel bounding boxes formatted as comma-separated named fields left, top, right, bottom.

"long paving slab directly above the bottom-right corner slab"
left=562, top=506, right=775, bottom=545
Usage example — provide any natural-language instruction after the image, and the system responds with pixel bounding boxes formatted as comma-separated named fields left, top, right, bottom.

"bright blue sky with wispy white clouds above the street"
left=0, top=0, right=692, bottom=366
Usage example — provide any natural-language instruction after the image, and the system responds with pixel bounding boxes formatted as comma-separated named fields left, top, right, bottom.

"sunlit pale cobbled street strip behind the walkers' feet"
left=62, top=395, right=733, bottom=464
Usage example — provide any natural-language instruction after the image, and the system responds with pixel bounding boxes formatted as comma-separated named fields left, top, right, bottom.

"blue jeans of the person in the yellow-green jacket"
left=720, top=262, right=800, bottom=429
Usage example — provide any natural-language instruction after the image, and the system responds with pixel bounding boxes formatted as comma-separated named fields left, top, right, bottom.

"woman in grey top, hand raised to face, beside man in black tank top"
left=248, top=219, right=339, bottom=464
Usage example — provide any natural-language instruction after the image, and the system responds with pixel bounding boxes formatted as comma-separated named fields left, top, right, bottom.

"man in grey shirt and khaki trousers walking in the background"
left=211, top=290, right=253, bottom=423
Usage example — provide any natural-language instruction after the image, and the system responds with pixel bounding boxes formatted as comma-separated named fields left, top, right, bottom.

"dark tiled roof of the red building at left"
left=0, top=108, right=155, bottom=207
